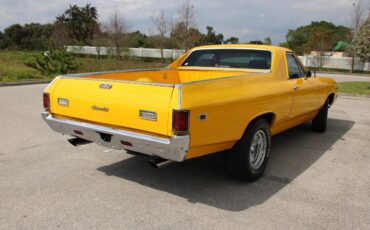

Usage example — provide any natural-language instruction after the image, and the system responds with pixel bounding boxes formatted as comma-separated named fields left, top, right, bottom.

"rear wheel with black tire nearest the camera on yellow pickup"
left=224, top=119, right=271, bottom=181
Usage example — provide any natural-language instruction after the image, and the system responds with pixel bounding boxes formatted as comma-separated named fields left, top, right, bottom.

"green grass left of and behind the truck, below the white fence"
left=0, top=51, right=169, bottom=82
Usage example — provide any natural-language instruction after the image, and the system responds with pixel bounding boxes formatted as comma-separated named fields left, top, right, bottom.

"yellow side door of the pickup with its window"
left=286, top=53, right=319, bottom=118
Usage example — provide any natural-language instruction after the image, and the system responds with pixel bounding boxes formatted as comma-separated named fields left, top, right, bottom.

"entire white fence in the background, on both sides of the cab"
left=67, top=46, right=370, bottom=71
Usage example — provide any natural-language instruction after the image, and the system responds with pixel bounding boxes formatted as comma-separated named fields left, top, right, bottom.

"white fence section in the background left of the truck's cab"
left=67, top=46, right=185, bottom=59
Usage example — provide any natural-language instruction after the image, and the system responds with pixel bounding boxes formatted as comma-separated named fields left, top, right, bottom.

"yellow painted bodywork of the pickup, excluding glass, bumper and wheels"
left=46, top=45, right=337, bottom=159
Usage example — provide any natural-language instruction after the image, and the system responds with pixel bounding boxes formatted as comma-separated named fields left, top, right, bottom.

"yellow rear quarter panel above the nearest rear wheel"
left=181, top=74, right=293, bottom=158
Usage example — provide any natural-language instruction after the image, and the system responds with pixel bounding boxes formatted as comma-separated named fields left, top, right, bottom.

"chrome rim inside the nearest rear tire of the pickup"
left=249, top=130, right=267, bottom=170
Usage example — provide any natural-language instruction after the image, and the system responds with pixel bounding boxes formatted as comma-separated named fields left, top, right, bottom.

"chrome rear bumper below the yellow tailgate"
left=41, top=112, right=189, bottom=162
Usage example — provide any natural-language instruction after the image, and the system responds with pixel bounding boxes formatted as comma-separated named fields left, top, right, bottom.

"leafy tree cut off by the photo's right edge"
left=353, top=14, right=370, bottom=62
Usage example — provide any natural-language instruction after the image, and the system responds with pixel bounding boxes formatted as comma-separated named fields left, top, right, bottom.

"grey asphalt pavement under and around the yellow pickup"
left=0, top=85, right=370, bottom=229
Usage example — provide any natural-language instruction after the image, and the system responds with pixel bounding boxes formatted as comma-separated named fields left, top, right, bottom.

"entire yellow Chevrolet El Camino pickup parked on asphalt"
left=42, top=45, right=338, bottom=181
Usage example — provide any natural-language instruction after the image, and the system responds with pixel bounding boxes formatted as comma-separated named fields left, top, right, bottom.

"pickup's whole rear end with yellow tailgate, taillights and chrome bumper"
left=42, top=76, right=189, bottom=161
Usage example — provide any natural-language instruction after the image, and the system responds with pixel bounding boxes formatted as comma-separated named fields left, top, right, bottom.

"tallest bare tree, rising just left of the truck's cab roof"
left=171, top=0, right=195, bottom=50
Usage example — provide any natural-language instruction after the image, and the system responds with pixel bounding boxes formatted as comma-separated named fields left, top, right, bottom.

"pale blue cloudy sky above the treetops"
left=0, top=0, right=370, bottom=44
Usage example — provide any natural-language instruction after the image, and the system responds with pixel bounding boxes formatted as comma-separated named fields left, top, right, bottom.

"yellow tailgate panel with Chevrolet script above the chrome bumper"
left=50, top=78, right=174, bottom=136
